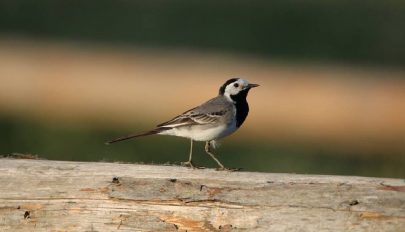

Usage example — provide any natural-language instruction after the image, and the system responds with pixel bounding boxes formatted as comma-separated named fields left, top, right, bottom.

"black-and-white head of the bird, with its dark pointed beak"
left=219, top=78, right=259, bottom=101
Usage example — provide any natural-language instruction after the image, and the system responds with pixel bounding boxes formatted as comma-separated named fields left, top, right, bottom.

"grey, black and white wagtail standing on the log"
left=106, top=78, right=259, bottom=169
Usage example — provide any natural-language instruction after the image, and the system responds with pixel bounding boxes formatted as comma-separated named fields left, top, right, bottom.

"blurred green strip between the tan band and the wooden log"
left=0, top=116, right=405, bottom=178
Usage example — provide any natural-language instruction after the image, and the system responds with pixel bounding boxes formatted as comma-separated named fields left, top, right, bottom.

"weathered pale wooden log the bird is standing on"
left=0, top=159, right=405, bottom=231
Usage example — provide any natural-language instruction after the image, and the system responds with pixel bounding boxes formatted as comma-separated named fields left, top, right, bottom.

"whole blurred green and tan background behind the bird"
left=0, top=0, right=405, bottom=178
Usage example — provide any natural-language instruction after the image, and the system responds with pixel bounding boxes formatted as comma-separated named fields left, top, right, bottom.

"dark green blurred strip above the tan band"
left=0, top=0, right=405, bottom=66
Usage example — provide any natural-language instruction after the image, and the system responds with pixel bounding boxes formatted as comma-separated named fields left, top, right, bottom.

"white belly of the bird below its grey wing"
left=159, top=123, right=237, bottom=141
